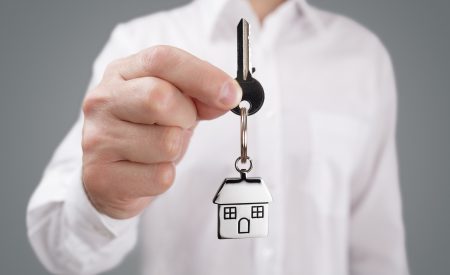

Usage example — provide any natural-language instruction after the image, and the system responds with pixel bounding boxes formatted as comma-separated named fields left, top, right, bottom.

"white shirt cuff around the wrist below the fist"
left=66, top=166, right=139, bottom=240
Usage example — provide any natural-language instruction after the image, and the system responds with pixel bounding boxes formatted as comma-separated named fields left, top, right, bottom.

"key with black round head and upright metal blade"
left=231, top=19, right=264, bottom=116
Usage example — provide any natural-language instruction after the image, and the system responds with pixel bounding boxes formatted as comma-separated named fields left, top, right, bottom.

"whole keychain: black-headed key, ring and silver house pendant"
left=213, top=19, right=272, bottom=239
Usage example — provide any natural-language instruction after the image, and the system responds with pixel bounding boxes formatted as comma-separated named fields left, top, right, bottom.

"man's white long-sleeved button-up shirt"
left=27, top=0, right=408, bottom=275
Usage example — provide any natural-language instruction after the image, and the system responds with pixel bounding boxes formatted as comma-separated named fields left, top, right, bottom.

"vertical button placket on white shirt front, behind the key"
left=250, top=35, right=283, bottom=275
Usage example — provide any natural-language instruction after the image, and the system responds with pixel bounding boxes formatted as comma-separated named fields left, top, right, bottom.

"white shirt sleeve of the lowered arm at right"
left=349, top=42, right=409, bottom=275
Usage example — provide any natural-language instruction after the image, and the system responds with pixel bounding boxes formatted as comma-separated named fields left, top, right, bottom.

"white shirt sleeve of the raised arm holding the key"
left=27, top=25, right=138, bottom=274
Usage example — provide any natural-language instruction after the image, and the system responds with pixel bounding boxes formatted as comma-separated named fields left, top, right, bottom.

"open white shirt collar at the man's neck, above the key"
left=195, top=0, right=322, bottom=41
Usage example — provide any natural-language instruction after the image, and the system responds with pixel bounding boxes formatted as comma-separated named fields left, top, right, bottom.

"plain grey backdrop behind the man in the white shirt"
left=0, top=0, right=450, bottom=275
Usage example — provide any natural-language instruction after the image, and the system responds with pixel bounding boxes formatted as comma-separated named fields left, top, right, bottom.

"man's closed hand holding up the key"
left=82, top=46, right=242, bottom=219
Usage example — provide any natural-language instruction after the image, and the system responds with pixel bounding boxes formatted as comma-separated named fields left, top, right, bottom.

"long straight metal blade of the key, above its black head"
left=237, top=18, right=250, bottom=80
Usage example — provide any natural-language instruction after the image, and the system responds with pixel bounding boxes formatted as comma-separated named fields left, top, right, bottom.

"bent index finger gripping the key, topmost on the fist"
left=107, top=46, right=242, bottom=119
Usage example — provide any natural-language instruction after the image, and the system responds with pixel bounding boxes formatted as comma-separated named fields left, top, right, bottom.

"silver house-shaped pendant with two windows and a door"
left=213, top=173, right=272, bottom=239
